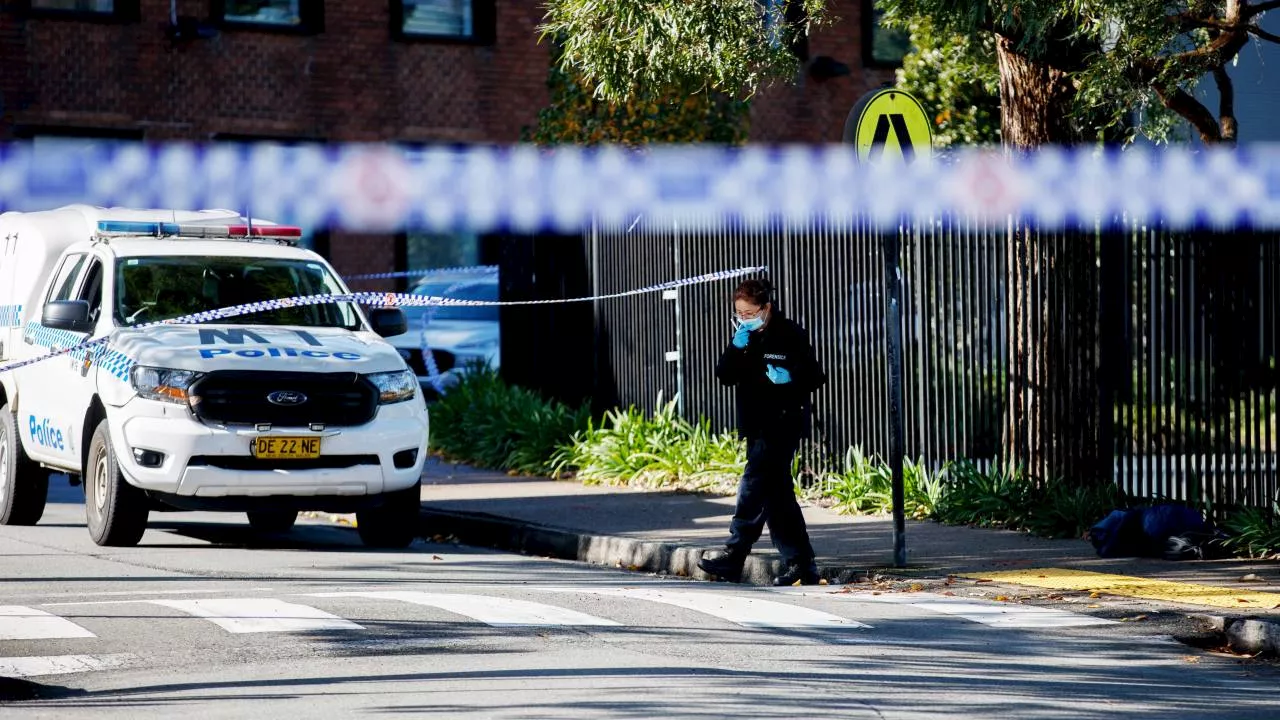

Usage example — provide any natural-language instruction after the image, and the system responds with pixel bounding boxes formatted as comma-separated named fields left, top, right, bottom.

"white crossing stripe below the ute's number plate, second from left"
left=143, top=597, right=364, bottom=633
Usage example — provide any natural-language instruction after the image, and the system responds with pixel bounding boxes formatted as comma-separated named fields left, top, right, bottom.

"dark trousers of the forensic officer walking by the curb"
left=726, top=437, right=814, bottom=565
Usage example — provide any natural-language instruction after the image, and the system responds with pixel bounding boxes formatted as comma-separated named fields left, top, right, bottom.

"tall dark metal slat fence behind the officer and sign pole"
left=582, top=219, right=1280, bottom=505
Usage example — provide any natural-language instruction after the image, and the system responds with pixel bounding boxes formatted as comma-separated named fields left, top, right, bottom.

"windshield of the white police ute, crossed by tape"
left=115, top=255, right=360, bottom=331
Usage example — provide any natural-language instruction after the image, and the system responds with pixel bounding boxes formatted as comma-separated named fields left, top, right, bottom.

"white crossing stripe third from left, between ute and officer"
left=307, top=591, right=620, bottom=628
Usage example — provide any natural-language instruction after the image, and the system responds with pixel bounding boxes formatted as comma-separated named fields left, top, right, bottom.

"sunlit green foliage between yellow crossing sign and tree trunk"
left=895, top=17, right=1000, bottom=147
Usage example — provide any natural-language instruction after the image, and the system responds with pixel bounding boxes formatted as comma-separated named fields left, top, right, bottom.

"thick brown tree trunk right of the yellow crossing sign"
left=997, top=37, right=1110, bottom=483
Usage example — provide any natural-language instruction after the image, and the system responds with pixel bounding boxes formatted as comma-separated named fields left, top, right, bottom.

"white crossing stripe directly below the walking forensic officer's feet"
left=545, top=588, right=870, bottom=629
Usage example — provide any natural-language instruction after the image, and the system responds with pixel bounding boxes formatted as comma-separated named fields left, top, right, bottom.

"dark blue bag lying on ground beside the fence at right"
left=1088, top=503, right=1213, bottom=559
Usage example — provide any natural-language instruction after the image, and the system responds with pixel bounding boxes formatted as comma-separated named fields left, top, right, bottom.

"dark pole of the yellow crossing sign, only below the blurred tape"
left=882, top=220, right=908, bottom=568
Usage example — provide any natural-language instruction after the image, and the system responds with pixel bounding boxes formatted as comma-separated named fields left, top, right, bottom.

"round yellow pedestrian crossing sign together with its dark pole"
left=844, top=87, right=933, bottom=568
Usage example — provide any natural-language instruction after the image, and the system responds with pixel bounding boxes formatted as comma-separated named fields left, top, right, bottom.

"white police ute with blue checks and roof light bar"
left=0, top=205, right=429, bottom=547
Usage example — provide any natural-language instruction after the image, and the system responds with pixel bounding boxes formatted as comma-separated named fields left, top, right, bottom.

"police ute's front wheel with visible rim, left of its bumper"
left=84, top=420, right=151, bottom=547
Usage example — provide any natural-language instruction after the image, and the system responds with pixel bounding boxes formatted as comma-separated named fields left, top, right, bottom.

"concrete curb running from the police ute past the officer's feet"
left=421, top=505, right=867, bottom=585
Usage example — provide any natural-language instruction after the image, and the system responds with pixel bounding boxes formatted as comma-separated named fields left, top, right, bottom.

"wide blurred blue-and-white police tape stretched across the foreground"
left=0, top=141, right=1280, bottom=229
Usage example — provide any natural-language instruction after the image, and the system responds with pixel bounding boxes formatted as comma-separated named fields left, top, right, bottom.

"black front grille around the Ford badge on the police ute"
left=191, top=370, right=378, bottom=427
